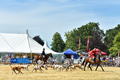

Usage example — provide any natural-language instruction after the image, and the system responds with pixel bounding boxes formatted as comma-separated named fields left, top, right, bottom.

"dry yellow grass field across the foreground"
left=0, top=65, right=120, bottom=80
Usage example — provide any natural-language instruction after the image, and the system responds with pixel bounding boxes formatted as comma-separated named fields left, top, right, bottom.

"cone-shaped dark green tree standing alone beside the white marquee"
left=51, top=32, right=65, bottom=52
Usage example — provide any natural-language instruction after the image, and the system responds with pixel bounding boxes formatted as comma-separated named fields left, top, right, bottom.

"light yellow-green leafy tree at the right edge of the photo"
left=109, top=32, right=120, bottom=56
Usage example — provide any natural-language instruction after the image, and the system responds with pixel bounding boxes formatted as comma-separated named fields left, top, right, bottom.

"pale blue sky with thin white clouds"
left=0, top=0, right=120, bottom=47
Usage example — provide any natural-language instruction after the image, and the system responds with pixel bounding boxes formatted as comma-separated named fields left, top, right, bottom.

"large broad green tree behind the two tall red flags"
left=65, top=22, right=104, bottom=51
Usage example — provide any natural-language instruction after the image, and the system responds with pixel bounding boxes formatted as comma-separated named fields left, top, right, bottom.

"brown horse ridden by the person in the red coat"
left=84, top=52, right=104, bottom=71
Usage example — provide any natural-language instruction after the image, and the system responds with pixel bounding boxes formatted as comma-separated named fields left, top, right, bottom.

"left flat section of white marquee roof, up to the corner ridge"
left=0, top=33, right=30, bottom=53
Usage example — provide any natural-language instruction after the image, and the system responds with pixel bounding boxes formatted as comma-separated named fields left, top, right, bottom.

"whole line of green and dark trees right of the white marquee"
left=37, top=22, right=120, bottom=56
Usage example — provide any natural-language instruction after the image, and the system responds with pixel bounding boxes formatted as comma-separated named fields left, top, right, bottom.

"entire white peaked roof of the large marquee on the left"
left=0, top=33, right=60, bottom=54
